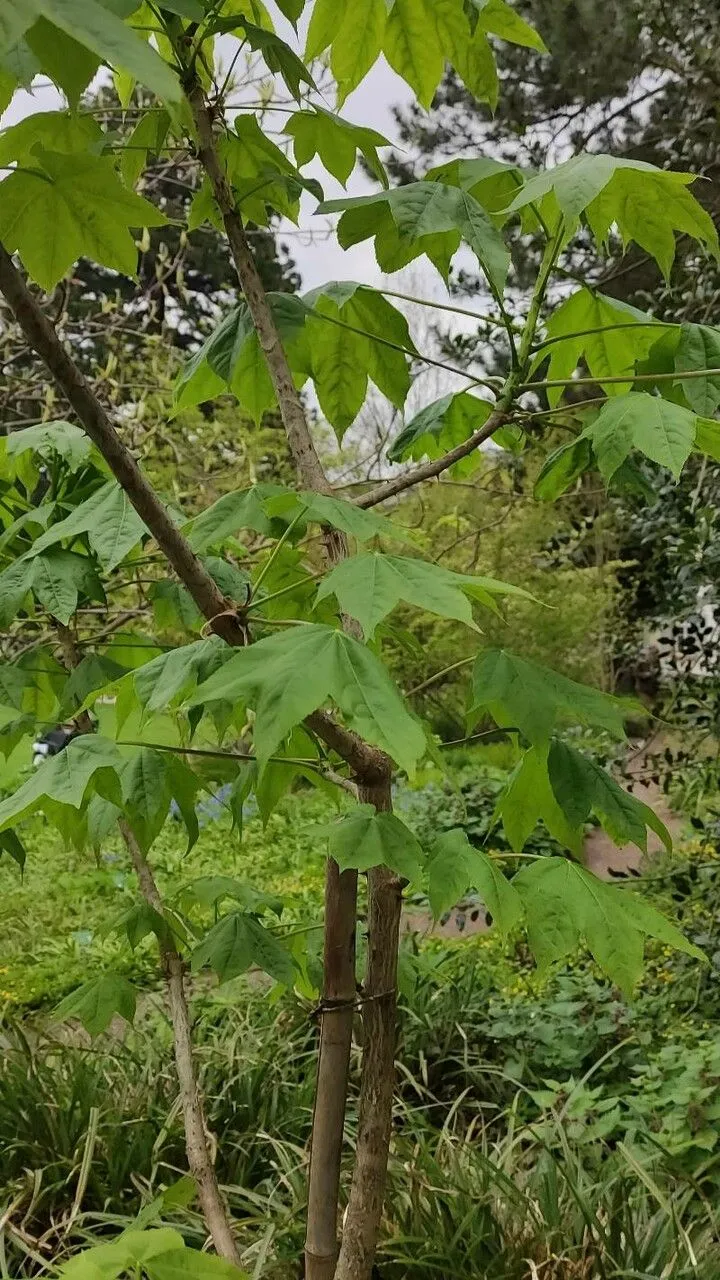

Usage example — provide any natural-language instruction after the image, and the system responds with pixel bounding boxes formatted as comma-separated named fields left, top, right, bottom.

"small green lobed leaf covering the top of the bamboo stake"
left=315, top=804, right=423, bottom=881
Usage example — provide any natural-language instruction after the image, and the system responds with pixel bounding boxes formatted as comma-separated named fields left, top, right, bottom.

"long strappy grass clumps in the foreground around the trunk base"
left=0, top=998, right=720, bottom=1280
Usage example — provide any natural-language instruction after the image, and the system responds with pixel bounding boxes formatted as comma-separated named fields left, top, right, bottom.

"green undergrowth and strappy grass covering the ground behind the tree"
left=0, top=755, right=720, bottom=1280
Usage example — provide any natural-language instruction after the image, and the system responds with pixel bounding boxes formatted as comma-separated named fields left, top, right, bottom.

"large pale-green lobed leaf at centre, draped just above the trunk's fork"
left=188, top=623, right=425, bottom=772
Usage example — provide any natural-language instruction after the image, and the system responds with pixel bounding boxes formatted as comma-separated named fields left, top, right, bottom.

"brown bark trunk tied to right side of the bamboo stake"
left=334, top=777, right=402, bottom=1280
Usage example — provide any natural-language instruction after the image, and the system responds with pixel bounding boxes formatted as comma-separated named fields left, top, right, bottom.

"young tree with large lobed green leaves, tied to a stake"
left=0, top=0, right=720, bottom=1280
